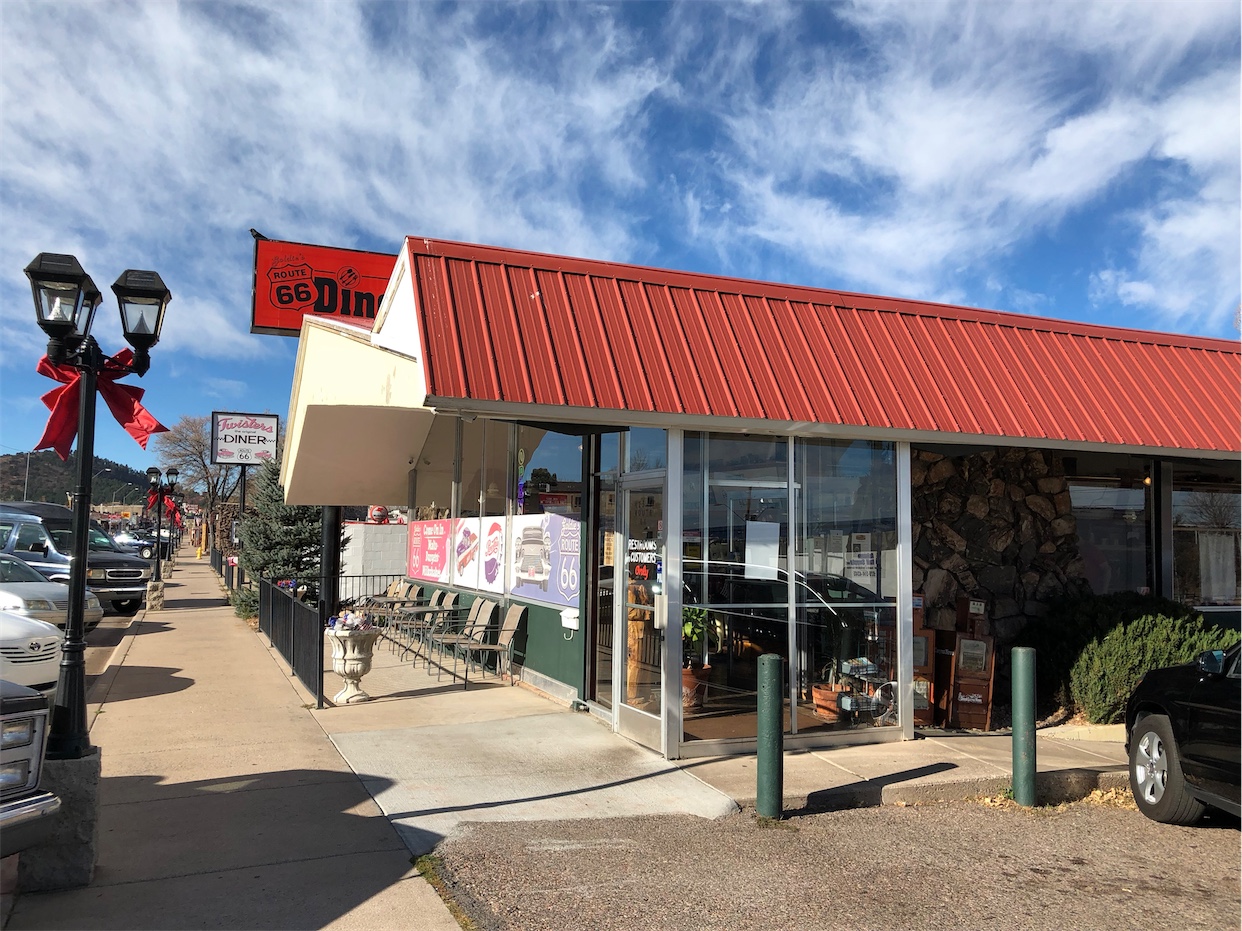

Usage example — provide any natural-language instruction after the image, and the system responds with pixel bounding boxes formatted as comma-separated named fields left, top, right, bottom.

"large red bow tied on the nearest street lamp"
left=35, top=349, right=168, bottom=459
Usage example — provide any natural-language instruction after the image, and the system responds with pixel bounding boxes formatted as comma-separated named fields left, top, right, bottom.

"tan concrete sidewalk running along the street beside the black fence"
left=6, top=550, right=458, bottom=931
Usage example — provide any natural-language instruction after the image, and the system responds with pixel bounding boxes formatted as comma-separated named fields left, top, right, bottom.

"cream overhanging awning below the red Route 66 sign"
left=281, top=317, right=435, bottom=505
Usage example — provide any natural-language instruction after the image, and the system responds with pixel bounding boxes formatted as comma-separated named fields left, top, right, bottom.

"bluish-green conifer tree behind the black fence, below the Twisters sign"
left=238, top=461, right=323, bottom=600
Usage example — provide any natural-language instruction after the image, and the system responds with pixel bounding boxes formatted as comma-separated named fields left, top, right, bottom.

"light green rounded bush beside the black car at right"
left=1069, top=614, right=1238, bottom=724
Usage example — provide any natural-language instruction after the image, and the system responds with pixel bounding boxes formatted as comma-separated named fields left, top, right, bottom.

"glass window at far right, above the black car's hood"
left=1172, top=463, right=1242, bottom=608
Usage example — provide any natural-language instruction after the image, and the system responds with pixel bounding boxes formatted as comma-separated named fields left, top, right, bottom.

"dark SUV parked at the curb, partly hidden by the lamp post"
left=0, top=501, right=152, bottom=614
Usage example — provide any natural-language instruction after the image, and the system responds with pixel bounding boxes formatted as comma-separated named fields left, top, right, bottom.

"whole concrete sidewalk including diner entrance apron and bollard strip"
left=7, top=554, right=1125, bottom=931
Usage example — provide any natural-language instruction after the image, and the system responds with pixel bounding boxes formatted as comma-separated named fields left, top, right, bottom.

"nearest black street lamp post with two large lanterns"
left=25, top=252, right=173, bottom=760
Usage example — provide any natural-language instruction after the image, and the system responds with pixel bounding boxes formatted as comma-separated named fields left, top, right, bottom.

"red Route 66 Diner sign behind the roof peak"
left=250, top=235, right=396, bottom=336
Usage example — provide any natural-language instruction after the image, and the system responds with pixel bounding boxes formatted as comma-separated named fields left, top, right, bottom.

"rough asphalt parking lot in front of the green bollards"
left=437, top=796, right=1240, bottom=931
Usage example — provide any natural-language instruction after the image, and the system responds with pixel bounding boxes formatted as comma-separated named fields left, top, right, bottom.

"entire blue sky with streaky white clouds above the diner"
left=0, top=0, right=1242, bottom=468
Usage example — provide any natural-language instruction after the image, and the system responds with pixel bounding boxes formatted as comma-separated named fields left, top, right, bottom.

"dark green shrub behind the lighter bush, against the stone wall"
left=1013, top=592, right=1196, bottom=713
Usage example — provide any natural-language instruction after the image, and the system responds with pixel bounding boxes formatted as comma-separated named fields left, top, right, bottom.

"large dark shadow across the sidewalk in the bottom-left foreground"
left=9, top=768, right=409, bottom=929
